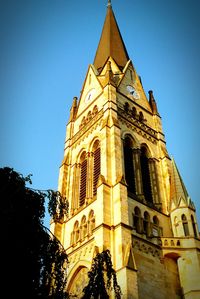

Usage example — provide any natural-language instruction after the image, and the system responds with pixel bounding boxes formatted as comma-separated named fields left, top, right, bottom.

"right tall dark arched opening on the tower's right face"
left=140, top=147, right=153, bottom=203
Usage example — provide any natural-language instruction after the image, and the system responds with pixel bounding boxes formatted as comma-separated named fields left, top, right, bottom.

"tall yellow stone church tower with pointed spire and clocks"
left=51, top=1, right=200, bottom=299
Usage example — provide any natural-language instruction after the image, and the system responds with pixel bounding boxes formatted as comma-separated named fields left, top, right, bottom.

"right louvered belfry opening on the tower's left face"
left=93, top=140, right=101, bottom=196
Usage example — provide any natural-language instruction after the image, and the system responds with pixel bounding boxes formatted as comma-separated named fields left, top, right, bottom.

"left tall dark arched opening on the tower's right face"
left=124, top=137, right=136, bottom=194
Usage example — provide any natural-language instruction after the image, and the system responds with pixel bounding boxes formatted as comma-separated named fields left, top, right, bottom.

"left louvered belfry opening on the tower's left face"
left=79, top=153, right=87, bottom=206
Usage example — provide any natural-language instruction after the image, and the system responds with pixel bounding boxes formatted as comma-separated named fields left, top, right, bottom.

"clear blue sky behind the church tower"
left=0, top=0, right=200, bottom=226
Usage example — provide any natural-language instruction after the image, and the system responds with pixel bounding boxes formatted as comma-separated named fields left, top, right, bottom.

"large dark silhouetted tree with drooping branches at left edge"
left=0, top=167, right=68, bottom=299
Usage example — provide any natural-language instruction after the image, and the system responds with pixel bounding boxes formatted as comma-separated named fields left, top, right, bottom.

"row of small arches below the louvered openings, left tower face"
left=71, top=210, right=95, bottom=246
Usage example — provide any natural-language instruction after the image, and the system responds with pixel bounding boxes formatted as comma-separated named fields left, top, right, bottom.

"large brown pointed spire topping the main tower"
left=94, top=0, right=129, bottom=69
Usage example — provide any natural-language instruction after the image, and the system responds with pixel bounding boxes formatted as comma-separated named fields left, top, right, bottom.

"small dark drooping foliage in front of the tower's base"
left=82, top=250, right=121, bottom=299
